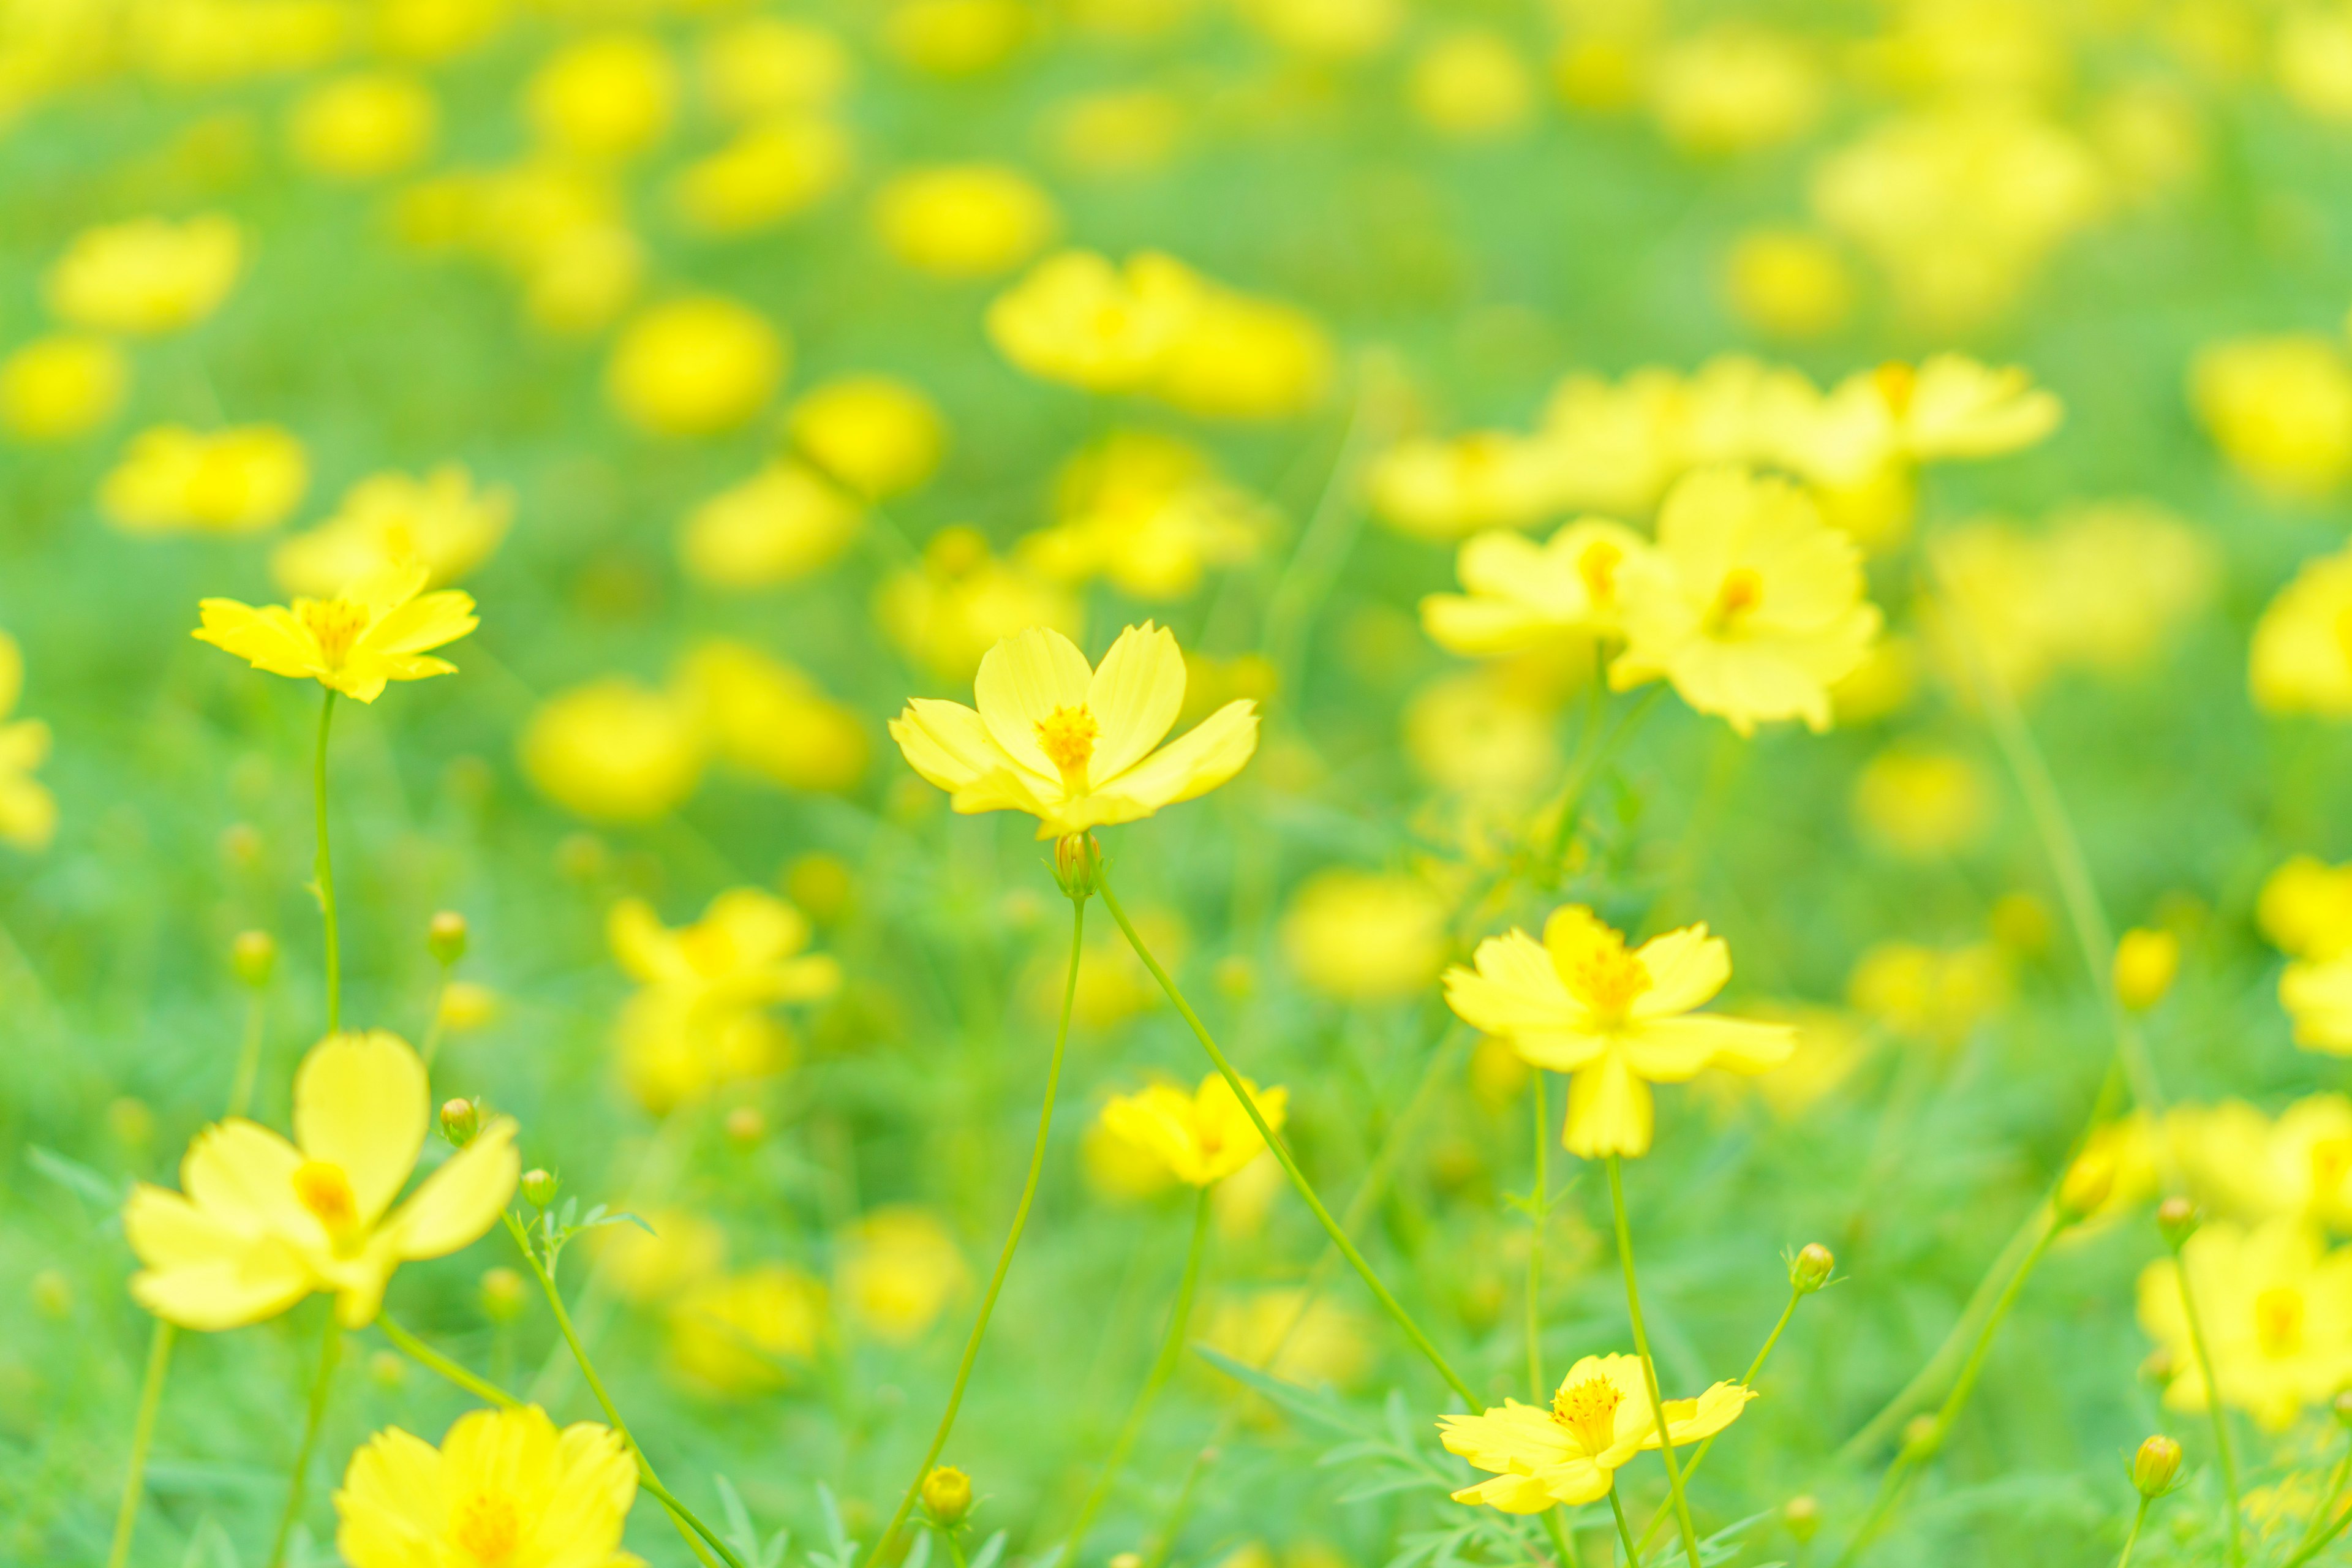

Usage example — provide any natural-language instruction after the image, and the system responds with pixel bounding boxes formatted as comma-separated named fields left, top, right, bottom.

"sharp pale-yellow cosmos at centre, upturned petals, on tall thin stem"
left=889, top=620, right=1258, bottom=839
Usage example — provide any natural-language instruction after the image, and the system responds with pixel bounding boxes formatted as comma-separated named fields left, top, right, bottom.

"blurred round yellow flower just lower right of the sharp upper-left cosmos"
left=518, top=675, right=703, bottom=823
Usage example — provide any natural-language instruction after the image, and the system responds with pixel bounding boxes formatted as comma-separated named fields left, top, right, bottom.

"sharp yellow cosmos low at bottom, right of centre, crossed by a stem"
left=1437, top=1357, right=1755, bottom=1514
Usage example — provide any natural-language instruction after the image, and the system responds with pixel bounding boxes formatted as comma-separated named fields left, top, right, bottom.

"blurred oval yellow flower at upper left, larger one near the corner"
left=45, top=214, right=244, bottom=334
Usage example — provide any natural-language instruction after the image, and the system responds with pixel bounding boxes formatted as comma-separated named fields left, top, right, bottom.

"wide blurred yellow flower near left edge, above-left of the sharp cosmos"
left=99, top=426, right=311, bottom=533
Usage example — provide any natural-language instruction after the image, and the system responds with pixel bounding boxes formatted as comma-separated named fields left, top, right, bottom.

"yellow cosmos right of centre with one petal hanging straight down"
left=1447, top=905, right=1797, bottom=1159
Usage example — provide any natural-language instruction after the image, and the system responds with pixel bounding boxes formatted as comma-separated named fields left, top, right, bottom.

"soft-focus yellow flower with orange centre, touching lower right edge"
left=2140, top=1220, right=2352, bottom=1431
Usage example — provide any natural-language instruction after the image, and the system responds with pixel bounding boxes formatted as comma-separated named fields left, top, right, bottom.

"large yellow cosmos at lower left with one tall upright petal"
left=123, top=1030, right=518, bottom=1329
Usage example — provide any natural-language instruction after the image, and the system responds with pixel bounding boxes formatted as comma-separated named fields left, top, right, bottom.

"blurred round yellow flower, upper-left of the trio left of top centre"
left=605, top=294, right=790, bottom=435
